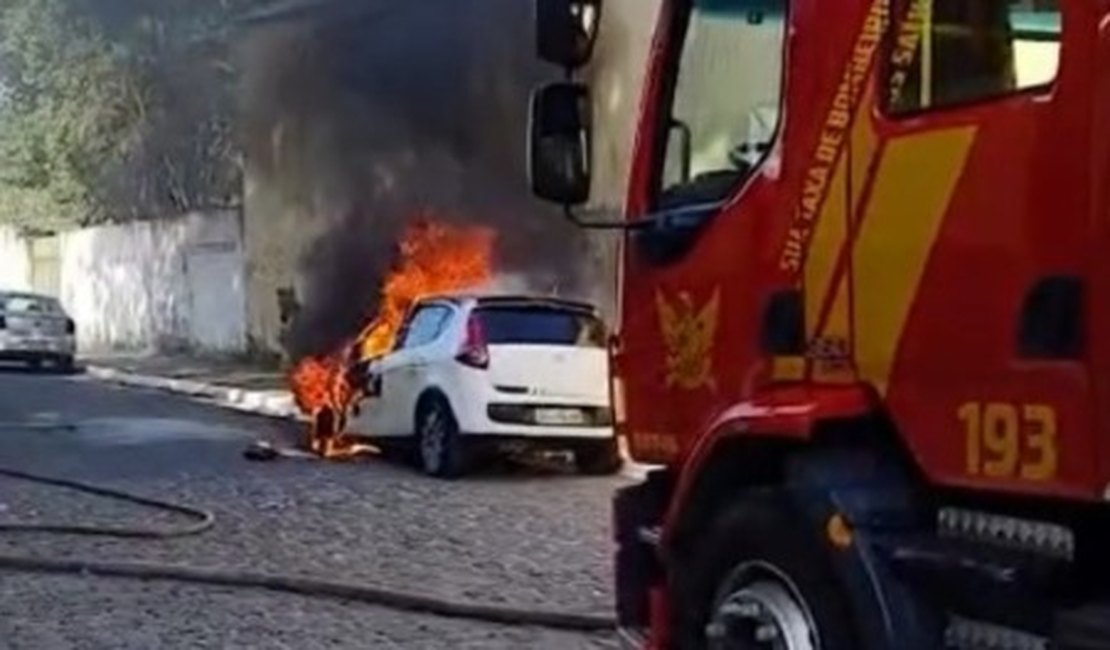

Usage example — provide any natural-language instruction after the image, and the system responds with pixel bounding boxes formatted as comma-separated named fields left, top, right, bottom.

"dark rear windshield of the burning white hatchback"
left=477, top=307, right=605, bottom=347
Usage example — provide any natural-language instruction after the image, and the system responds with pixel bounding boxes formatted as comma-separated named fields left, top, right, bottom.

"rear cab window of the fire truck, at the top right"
left=886, top=0, right=1061, bottom=114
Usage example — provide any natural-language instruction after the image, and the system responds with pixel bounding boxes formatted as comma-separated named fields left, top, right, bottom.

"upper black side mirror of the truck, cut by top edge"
left=536, top=0, right=602, bottom=70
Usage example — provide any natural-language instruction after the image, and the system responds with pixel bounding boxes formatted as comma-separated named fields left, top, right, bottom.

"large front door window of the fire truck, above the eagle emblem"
left=657, top=0, right=786, bottom=209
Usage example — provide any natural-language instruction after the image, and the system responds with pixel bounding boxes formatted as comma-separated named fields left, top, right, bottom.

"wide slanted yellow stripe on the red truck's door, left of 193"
left=852, top=126, right=976, bottom=394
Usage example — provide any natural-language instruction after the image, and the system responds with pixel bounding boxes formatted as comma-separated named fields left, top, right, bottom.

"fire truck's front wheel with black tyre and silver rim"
left=672, top=495, right=858, bottom=650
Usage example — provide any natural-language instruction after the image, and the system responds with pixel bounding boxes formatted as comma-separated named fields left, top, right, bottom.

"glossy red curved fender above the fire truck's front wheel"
left=662, top=384, right=880, bottom=547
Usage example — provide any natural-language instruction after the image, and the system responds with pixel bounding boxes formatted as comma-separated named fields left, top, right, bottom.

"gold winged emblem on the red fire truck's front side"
left=655, top=288, right=720, bottom=390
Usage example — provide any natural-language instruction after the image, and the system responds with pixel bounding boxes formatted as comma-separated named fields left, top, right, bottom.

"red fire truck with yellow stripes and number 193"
left=528, top=0, right=1110, bottom=650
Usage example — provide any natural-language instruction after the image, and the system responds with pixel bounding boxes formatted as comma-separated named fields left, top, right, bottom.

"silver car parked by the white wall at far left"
left=0, top=291, right=77, bottom=370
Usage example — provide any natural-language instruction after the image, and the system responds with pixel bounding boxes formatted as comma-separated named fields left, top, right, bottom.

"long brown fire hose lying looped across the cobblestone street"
left=0, top=467, right=615, bottom=632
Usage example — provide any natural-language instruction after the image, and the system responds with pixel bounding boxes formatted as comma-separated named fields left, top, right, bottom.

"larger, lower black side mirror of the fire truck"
left=528, top=82, right=593, bottom=206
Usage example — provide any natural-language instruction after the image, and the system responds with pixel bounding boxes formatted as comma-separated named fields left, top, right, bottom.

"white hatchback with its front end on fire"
left=347, top=295, right=620, bottom=478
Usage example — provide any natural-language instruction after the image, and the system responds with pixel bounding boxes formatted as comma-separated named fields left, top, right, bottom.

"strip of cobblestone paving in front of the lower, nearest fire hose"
left=0, top=576, right=618, bottom=650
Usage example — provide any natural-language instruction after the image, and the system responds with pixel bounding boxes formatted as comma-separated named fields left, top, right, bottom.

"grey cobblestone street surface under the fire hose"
left=0, top=368, right=620, bottom=650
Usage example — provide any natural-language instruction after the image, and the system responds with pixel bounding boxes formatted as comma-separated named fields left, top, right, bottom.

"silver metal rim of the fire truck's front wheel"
left=705, top=562, right=821, bottom=650
